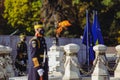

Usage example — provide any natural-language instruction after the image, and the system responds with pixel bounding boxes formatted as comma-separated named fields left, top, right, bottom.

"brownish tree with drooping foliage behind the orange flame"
left=41, top=0, right=81, bottom=37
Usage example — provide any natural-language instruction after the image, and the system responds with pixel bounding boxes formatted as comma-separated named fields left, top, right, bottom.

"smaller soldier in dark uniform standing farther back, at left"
left=15, top=34, right=28, bottom=76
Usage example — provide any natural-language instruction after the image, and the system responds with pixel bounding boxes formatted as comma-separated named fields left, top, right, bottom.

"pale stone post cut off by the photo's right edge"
left=114, top=45, right=120, bottom=79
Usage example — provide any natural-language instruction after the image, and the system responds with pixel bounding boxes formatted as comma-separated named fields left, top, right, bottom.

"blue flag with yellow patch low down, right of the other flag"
left=92, top=12, right=104, bottom=45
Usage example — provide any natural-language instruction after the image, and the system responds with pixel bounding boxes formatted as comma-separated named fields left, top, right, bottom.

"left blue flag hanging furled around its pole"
left=82, top=11, right=95, bottom=63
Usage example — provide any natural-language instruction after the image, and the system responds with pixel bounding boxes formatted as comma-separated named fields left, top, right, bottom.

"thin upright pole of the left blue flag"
left=86, top=10, right=89, bottom=70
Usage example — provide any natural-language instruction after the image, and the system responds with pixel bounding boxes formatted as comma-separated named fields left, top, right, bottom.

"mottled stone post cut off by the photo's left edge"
left=0, top=45, right=15, bottom=80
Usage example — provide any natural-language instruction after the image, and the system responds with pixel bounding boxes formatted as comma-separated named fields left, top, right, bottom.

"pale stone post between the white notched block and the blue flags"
left=63, top=44, right=81, bottom=80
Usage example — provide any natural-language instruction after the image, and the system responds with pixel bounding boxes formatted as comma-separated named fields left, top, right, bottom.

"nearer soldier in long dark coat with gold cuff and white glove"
left=28, top=24, right=48, bottom=80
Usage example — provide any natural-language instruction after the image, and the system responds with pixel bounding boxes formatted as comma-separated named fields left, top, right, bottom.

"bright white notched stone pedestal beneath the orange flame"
left=48, top=45, right=64, bottom=80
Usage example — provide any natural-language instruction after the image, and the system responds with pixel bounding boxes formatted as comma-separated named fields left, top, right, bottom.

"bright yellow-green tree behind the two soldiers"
left=3, top=0, right=41, bottom=34
